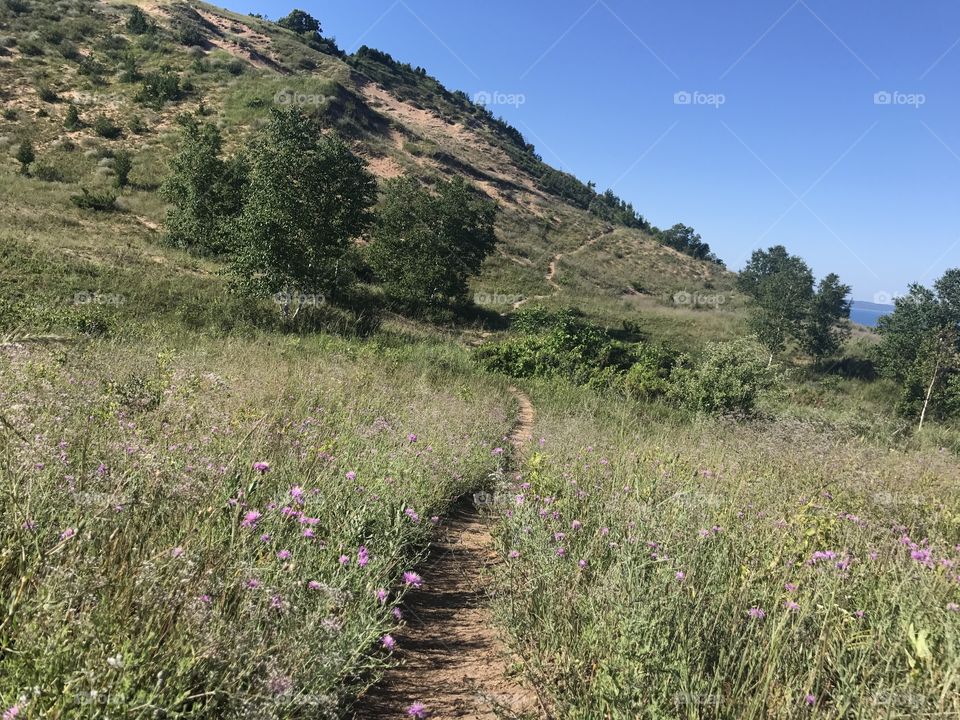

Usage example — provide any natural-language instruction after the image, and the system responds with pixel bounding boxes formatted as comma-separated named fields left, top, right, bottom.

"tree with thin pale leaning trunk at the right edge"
left=876, top=269, right=960, bottom=428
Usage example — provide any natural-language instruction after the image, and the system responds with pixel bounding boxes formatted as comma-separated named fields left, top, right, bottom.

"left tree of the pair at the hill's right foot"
left=737, top=245, right=814, bottom=364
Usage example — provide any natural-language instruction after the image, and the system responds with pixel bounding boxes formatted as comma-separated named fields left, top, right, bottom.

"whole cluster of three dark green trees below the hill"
left=161, top=108, right=497, bottom=320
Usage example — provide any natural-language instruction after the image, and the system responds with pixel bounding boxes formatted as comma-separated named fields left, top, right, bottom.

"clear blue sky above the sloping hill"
left=220, top=0, right=960, bottom=302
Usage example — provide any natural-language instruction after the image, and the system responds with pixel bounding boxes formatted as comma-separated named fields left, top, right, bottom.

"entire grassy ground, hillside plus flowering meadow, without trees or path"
left=0, top=0, right=960, bottom=720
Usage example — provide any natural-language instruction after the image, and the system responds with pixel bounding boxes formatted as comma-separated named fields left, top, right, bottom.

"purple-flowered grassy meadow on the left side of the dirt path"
left=0, top=336, right=512, bottom=719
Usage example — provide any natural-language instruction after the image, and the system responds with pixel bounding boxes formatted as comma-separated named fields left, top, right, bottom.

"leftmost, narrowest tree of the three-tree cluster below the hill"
left=160, top=115, right=246, bottom=255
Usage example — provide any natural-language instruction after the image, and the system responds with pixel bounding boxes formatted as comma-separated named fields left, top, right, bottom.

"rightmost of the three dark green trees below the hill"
left=367, top=178, right=497, bottom=309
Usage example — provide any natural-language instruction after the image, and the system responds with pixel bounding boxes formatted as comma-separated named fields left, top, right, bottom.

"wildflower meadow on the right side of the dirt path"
left=496, top=387, right=960, bottom=719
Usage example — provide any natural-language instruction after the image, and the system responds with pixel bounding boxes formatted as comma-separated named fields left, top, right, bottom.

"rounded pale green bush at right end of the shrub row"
left=670, top=339, right=777, bottom=413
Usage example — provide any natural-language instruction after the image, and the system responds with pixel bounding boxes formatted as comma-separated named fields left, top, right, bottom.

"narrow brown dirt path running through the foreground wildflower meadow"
left=354, top=388, right=545, bottom=720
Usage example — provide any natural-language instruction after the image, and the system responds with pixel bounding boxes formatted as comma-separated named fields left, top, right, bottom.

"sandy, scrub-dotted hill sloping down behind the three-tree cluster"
left=0, top=0, right=737, bottom=341
